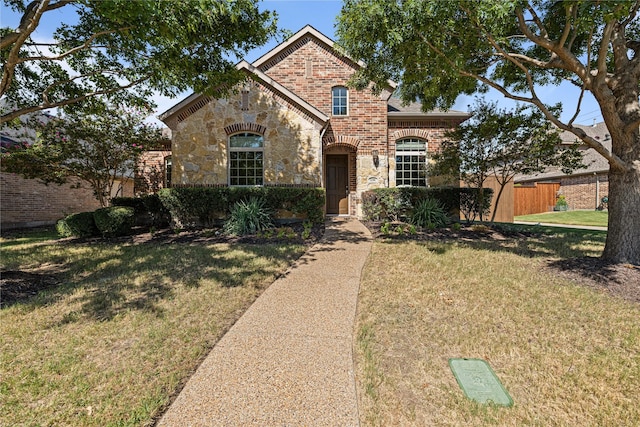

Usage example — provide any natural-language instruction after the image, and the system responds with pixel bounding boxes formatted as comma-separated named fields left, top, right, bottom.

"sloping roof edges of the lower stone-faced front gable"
left=158, top=60, right=329, bottom=125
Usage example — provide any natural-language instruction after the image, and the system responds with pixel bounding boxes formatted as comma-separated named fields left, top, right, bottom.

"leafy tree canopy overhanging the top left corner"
left=0, top=0, right=277, bottom=123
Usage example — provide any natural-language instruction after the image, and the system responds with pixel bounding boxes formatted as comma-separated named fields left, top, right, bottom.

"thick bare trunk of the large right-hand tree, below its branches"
left=602, top=160, right=640, bottom=265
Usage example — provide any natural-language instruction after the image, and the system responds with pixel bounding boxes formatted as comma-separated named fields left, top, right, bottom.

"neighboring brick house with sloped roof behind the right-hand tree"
left=514, top=122, right=611, bottom=214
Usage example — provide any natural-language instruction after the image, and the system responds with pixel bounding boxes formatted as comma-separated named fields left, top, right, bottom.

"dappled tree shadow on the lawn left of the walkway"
left=2, top=240, right=300, bottom=324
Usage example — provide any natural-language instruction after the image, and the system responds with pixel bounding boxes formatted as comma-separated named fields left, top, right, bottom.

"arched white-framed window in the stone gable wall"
left=229, top=132, right=264, bottom=186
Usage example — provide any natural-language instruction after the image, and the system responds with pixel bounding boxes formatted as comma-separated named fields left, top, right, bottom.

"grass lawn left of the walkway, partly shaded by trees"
left=0, top=233, right=304, bottom=426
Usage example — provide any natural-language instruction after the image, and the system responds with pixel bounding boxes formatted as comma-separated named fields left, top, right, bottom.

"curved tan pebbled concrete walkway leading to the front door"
left=158, top=218, right=371, bottom=426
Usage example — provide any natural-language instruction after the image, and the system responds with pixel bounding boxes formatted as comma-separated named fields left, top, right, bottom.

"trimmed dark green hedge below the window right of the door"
left=362, top=187, right=493, bottom=221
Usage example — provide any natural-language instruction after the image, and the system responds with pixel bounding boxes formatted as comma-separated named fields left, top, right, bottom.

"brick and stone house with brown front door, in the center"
left=160, top=26, right=469, bottom=215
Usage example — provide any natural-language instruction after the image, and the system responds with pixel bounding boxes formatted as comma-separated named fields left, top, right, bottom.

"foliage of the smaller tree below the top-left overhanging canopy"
left=2, top=107, right=162, bottom=206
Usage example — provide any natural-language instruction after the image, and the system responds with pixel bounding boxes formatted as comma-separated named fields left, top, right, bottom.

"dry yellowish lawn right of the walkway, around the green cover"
left=356, top=238, right=640, bottom=426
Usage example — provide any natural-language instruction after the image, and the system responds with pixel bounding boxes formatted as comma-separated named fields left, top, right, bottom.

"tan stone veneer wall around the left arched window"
left=172, top=83, right=322, bottom=186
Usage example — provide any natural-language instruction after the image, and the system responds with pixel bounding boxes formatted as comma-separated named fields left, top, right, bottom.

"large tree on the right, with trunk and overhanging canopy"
left=337, top=0, right=640, bottom=264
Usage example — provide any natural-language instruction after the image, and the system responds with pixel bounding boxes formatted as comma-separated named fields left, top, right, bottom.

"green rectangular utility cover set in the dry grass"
left=449, top=359, right=513, bottom=406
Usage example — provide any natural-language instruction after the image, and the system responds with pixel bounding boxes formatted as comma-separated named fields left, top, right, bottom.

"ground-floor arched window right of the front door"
left=396, top=138, right=427, bottom=187
